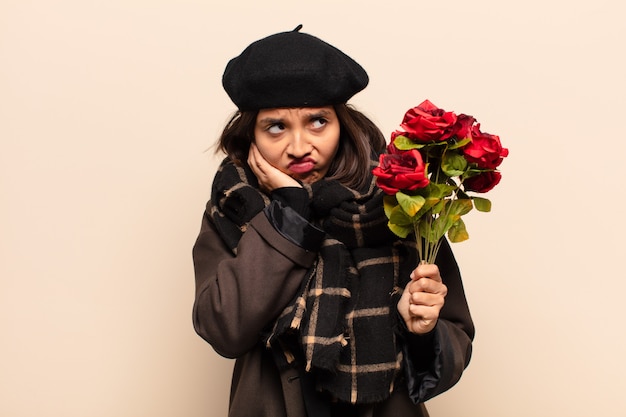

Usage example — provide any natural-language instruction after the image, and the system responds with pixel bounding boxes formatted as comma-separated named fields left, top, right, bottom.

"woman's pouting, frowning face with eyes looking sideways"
left=254, top=106, right=340, bottom=184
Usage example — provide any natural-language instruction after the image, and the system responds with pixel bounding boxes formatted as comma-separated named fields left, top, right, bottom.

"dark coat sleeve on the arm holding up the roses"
left=400, top=240, right=474, bottom=404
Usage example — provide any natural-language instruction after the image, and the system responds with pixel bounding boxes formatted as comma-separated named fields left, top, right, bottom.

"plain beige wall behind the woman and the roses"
left=0, top=0, right=626, bottom=417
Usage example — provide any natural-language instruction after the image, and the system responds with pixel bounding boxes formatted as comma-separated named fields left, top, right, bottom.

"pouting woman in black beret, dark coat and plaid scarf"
left=193, top=27, right=474, bottom=417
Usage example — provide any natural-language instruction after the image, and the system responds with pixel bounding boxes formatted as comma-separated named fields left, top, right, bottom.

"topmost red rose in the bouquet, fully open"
left=391, top=100, right=457, bottom=142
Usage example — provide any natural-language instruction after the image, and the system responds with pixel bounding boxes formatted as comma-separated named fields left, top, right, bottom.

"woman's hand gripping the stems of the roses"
left=398, top=264, right=448, bottom=334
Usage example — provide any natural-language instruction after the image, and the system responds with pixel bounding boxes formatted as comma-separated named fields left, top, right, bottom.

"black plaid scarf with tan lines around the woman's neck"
left=210, top=159, right=417, bottom=403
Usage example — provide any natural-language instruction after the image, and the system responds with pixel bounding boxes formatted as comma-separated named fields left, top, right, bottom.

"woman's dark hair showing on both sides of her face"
left=217, top=104, right=386, bottom=189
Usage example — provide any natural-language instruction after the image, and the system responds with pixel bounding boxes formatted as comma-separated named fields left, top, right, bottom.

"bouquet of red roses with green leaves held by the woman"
left=372, top=100, right=509, bottom=263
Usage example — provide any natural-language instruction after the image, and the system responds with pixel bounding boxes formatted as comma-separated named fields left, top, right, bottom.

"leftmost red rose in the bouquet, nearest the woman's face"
left=372, top=149, right=428, bottom=195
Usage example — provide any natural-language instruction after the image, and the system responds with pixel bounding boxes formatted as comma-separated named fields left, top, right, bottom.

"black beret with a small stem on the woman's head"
left=222, top=25, right=369, bottom=110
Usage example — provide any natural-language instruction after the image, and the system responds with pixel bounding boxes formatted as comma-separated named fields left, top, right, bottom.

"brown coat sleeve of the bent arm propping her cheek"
left=193, top=205, right=317, bottom=358
